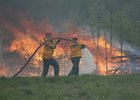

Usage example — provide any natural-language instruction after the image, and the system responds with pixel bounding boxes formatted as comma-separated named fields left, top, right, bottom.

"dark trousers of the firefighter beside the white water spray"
left=69, top=57, right=80, bottom=75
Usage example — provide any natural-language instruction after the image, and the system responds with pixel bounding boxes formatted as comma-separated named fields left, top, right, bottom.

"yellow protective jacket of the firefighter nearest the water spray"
left=70, top=43, right=82, bottom=58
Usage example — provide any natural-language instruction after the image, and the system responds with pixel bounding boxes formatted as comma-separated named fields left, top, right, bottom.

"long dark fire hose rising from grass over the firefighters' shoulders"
left=11, top=38, right=73, bottom=78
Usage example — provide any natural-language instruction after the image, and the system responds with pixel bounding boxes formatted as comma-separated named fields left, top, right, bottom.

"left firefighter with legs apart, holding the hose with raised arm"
left=42, top=31, right=60, bottom=77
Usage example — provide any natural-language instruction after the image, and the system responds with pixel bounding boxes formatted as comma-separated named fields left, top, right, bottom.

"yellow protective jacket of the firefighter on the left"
left=42, top=38, right=56, bottom=59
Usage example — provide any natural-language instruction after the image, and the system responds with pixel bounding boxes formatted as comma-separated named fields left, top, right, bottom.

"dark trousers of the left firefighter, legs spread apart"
left=42, top=58, right=59, bottom=76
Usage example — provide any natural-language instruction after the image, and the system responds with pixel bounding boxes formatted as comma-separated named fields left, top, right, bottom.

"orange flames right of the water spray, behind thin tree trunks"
left=80, top=36, right=128, bottom=75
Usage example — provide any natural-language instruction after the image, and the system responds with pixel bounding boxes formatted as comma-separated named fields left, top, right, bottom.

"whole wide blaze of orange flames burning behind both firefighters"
left=0, top=10, right=140, bottom=76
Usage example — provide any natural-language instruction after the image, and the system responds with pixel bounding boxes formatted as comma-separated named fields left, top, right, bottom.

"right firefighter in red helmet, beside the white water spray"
left=69, top=34, right=86, bottom=76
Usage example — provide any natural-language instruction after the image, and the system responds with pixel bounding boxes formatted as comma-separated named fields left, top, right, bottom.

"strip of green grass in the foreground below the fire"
left=0, top=75, right=140, bottom=100
